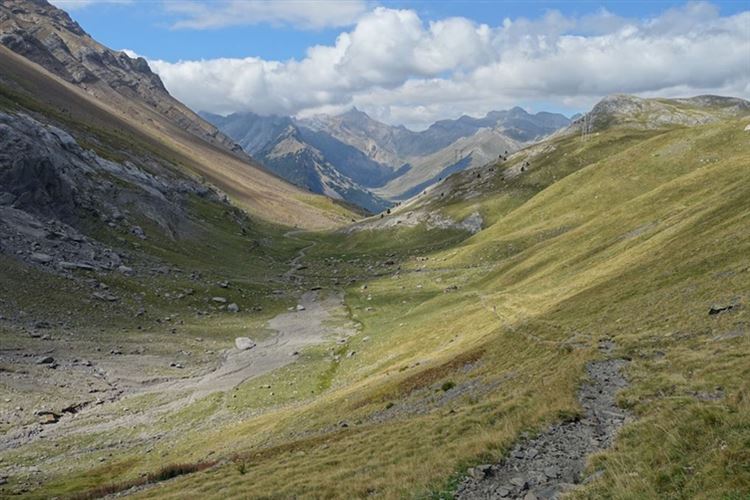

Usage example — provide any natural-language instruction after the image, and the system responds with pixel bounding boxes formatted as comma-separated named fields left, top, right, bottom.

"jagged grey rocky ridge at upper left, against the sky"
left=0, top=0, right=247, bottom=158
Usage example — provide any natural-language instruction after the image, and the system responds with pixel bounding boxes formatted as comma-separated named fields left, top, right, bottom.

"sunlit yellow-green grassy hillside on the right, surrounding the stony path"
left=55, top=120, right=750, bottom=498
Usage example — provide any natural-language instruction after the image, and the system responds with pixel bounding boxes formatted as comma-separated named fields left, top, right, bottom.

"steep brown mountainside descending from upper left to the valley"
left=0, top=1, right=350, bottom=228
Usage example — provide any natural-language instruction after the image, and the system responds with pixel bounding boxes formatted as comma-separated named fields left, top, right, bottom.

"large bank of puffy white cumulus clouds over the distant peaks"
left=149, top=2, right=750, bottom=128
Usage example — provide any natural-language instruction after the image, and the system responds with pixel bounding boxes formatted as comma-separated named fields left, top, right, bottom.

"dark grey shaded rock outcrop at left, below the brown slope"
left=0, top=113, right=228, bottom=273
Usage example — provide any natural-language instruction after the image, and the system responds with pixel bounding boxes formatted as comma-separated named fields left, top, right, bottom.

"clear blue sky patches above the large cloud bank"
left=60, top=0, right=750, bottom=62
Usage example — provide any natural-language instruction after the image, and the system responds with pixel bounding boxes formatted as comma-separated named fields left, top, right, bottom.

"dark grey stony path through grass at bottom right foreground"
left=456, top=342, right=628, bottom=500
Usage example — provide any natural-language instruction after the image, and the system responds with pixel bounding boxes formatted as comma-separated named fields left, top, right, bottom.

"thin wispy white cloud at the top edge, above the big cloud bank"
left=169, top=0, right=367, bottom=29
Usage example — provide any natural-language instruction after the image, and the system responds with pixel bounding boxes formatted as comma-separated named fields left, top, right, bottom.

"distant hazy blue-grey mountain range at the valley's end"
left=201, top=107, right=570, bottom=212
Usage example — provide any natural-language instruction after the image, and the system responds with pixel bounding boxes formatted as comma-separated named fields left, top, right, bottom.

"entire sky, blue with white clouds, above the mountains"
left=52, top=0, right=750, bottom=129
